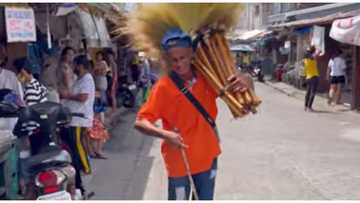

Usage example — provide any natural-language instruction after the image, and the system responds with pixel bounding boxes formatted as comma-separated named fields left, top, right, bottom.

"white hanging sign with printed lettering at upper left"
left=5, top=7, right=36, bottom=42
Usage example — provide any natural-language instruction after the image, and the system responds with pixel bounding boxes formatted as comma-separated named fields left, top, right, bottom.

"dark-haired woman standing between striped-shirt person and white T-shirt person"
left=56, top=47, right=77, bottom=102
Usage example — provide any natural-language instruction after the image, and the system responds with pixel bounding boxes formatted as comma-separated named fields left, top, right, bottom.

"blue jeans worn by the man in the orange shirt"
left=168, top=159, right=217, bottom=200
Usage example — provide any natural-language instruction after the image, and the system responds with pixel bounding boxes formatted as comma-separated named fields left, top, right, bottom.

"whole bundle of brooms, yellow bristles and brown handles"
left=117, top=3, right=261, bottom=118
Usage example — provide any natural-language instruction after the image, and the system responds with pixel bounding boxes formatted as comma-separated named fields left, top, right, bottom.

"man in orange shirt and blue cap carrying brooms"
left=135, top=29, right=248, bottom=200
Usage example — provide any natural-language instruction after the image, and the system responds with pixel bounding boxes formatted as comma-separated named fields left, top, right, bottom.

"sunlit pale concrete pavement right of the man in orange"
left=216, top=81, right=360, bottom=200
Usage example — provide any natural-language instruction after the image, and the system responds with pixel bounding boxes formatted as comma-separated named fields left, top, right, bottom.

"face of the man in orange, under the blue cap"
left=168, top=47, right=192, bottom=75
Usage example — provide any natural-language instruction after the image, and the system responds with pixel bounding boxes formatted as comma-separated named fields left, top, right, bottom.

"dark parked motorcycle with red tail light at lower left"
left=0, top=97, right=83, bottom=200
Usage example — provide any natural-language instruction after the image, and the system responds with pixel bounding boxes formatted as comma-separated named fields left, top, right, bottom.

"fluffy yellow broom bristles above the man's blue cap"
left=116, top=3, right=242, bottom=58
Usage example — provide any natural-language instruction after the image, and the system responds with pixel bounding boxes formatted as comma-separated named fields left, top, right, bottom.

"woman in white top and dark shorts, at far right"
left=327, top=49, right=346, bottom=105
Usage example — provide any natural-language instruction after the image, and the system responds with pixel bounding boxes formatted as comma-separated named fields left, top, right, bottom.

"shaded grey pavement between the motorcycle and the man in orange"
left=85, top=109, right=166, bottom=200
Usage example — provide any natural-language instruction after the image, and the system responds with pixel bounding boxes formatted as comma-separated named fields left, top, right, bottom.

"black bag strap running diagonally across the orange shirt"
left=169, top=71, right=217, bottom=129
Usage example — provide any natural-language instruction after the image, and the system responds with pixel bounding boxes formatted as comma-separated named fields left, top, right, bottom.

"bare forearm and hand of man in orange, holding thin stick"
left=135, top=119, right=187, bottom=148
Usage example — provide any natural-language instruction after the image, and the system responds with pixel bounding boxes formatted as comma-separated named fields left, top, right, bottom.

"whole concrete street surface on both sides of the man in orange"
left=88, top=84, right=360, bottom=200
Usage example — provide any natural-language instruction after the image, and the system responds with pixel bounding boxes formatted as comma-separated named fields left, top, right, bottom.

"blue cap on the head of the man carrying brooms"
left=161, top=28, right=192, bottom=51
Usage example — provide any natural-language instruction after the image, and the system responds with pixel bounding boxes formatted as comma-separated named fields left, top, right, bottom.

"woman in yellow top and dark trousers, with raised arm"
left=303, top=48, right=319, bottom=111
